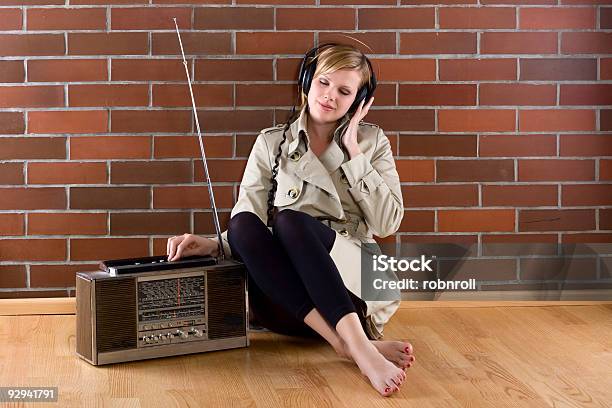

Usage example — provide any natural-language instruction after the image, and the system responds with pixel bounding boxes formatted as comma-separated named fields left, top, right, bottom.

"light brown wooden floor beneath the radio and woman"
left=0, top=304, right=612, bottom=408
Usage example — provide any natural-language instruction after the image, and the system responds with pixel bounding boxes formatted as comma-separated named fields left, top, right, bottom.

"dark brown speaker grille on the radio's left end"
left=96, top=279, right=138, bottom=352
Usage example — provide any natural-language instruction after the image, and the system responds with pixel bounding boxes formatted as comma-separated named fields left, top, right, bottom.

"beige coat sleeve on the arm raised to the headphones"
left=342, top=128, right=404, bottom=238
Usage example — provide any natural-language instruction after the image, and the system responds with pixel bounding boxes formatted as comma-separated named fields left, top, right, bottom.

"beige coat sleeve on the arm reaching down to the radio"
left=213, top=133, right=272, bottom=257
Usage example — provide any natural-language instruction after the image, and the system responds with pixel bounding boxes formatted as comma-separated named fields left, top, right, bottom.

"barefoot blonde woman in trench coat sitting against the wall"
left=167, top=44, right=414, bottom=396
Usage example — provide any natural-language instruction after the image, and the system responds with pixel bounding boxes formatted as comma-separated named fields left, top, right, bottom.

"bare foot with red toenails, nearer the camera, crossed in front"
left=346, top=342, right=406, bottom=397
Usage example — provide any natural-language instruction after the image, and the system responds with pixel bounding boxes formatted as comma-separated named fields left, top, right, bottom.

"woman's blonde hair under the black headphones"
left=299, top=44, right=372, bottom=110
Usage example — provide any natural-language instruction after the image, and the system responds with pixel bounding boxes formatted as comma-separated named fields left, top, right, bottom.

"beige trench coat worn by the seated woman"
left=213, top=105, right=404, bottom=338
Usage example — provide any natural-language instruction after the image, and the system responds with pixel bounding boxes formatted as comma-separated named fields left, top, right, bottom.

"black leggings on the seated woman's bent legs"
left=227, top=210, right=367, bottom=337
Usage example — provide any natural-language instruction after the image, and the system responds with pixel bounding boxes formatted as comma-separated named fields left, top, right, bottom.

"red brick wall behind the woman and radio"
left=0, top=0, right=612, bottom=297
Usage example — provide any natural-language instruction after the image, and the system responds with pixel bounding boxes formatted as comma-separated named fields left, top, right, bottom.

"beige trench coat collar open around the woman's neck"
left=287, top=105, right=350, bottom=173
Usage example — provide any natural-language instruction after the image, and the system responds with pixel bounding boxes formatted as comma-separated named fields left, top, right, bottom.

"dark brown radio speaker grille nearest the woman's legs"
left=207, top=269, right=246, bottom=339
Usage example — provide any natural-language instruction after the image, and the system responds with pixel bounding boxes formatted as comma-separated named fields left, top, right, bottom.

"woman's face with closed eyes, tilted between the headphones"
left=308, top=69, right=361, bottom=124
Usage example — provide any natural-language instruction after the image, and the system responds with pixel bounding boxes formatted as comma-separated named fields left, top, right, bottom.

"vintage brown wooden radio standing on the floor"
left=76, top=257, right=249, bottom=365
